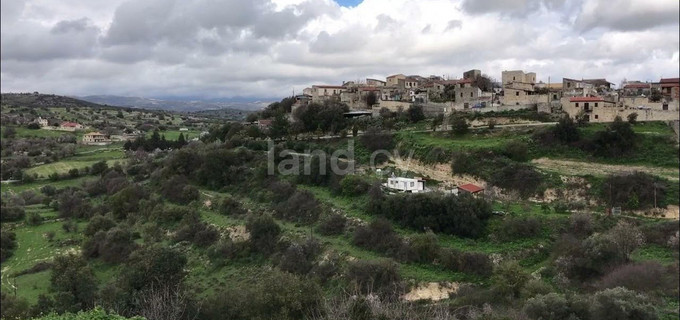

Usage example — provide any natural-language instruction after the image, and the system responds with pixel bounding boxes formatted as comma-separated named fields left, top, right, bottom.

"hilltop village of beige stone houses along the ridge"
left=293, top=69, right=680, bottom=122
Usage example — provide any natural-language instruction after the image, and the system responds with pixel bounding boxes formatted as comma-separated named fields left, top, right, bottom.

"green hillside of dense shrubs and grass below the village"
left=1, top=99, right=679, bottom=320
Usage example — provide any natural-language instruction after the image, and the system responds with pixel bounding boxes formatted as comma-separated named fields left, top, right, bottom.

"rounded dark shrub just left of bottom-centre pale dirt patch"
left=346, top=260, right=401, bottom=293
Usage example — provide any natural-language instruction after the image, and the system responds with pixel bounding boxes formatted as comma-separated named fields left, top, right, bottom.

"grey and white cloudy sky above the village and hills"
left=0, top=0, right=680, bottom=99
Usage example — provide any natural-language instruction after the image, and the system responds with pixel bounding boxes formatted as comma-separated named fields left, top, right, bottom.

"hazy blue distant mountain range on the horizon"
left=75, top=95, right=270, bottom=112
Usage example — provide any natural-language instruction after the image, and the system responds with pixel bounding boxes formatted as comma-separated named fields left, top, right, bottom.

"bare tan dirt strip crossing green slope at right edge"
left=531, top=158, right=680, bottom=181
